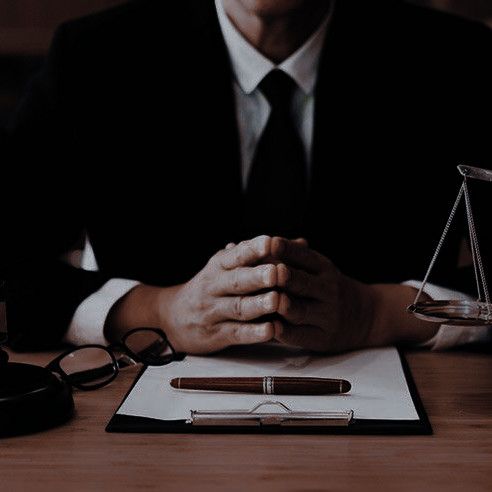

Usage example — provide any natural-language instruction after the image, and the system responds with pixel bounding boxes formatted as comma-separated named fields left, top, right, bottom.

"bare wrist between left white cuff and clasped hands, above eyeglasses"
left=104, top=284, right=177, bottom=342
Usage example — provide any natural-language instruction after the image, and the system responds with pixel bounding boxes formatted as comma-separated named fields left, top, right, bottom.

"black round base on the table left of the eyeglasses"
left=0, top=362, right=74, bottom=437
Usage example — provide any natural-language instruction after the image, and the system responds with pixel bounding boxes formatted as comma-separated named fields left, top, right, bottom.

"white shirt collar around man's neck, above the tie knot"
left=215, top=0, right=335, bottom=94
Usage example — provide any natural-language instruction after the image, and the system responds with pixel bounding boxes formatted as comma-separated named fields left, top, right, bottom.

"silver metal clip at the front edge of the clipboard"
left=188, top=401, right=354, bottom=427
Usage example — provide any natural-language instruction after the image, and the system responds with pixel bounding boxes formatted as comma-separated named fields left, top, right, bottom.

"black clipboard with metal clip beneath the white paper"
left=106, top=350, right=432, bottom=435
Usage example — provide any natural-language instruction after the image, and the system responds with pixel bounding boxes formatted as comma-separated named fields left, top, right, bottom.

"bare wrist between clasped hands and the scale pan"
left=368, top=284, right=439, bottom=346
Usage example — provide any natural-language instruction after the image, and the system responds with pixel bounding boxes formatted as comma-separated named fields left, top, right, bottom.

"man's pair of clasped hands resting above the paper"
left=162, top=236, right=373, bottom=354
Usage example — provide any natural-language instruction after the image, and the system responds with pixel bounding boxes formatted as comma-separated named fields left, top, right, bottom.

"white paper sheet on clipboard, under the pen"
left=118, top=344, right=418, bottom=420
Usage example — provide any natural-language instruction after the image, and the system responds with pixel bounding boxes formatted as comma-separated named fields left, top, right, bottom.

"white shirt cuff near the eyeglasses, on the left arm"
left=63, top=278, right=140, bottom=345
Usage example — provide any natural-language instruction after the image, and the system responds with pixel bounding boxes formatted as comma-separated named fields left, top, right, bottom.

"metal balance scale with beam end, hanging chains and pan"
left=407, top=165, right=492, bottom=326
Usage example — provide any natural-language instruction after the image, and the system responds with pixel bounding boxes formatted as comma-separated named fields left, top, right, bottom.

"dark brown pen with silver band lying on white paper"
left=170, top=376, right=352, bottom=395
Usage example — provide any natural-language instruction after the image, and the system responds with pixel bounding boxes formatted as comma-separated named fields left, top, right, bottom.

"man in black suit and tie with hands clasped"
left=4, top=0, right=492, bottom=353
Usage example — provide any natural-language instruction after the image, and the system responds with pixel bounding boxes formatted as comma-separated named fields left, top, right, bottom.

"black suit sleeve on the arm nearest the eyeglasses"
left=0, top=26, right=108, bottom=350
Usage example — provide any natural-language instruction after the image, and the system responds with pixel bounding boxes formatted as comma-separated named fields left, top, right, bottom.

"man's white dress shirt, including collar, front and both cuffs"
left=65, top=0, right=488, bottom=349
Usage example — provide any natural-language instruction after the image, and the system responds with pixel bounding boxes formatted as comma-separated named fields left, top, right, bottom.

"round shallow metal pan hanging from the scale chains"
left=407, top=301, right=492, bottom=326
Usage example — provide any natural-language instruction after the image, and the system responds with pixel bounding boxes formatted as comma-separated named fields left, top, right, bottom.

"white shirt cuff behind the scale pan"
left=403, top=280, right=492, bottom=350
